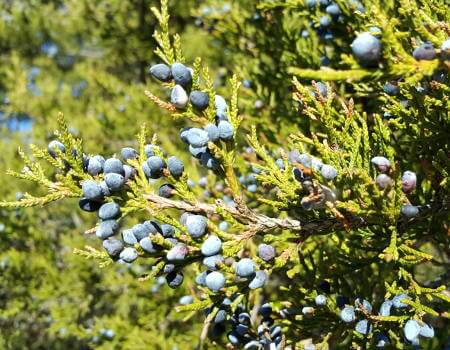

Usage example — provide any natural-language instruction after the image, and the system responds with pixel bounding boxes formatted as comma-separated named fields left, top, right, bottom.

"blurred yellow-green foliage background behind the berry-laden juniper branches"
left=0, top=0, right=225, bottom=350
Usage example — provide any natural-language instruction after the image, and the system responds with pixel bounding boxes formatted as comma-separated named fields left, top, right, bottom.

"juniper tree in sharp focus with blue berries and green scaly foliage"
left=2, top=1, right=450, bottom=349
